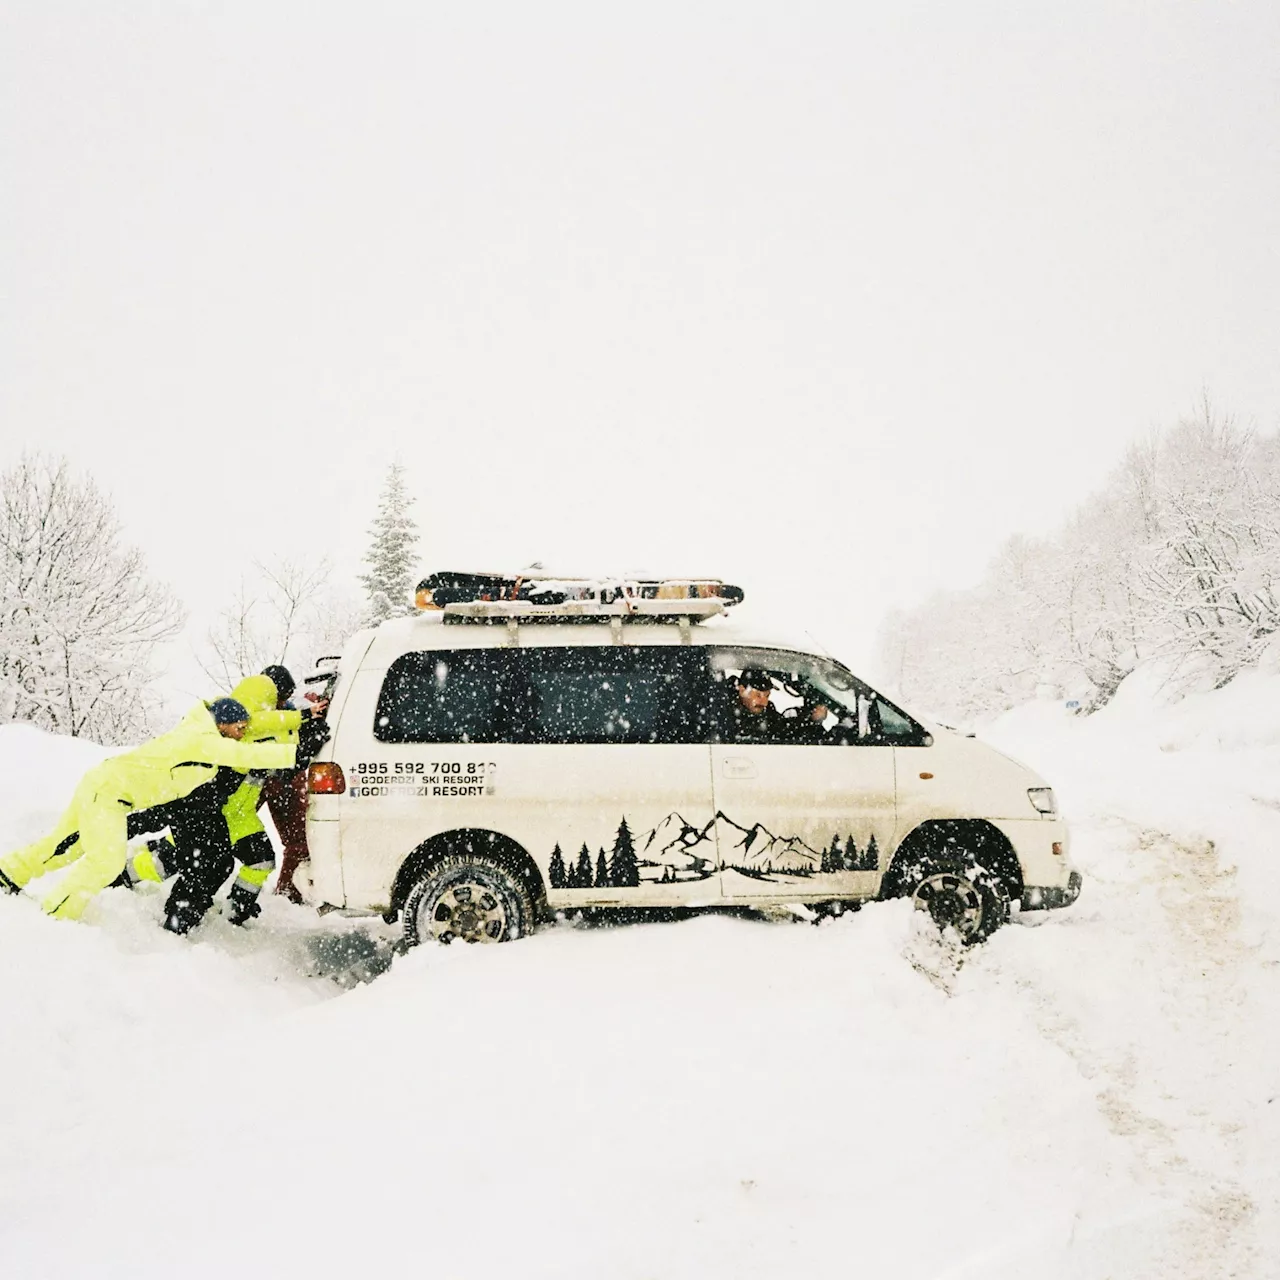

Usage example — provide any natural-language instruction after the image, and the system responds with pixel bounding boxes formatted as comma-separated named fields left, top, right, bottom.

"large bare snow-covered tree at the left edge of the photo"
left=0, top=454, right=184, bottom=744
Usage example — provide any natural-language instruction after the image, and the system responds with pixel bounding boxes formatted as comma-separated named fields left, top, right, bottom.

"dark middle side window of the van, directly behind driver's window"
left=521, top=645, right=700, bottom=742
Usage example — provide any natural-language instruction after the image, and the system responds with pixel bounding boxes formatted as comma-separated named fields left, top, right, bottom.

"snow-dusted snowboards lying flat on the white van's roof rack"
left=417, top=570, right=745, bottom=609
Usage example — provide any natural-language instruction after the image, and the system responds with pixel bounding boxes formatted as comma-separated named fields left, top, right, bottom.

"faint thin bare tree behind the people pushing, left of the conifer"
left=200, top=559, right=361, bottom=691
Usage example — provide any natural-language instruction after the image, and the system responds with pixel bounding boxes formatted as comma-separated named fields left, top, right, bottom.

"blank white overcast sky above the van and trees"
left=0, top=0, right=1280, bottom=701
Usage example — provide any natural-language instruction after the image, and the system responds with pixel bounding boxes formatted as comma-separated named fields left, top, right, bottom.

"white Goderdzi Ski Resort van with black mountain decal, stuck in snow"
left=299, top=586, right=1080, bottom=943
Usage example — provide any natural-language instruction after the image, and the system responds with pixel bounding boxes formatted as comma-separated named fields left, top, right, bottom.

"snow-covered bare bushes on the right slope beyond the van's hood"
left=881, top=402, right=1280, bottom=721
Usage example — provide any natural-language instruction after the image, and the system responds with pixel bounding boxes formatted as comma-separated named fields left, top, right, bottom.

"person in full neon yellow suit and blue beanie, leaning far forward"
left=0, top=698, right=296, bottom=920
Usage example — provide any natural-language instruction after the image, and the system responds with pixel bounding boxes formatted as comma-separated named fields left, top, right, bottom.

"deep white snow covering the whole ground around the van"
left=0, top=677, right=1280, bottom=1280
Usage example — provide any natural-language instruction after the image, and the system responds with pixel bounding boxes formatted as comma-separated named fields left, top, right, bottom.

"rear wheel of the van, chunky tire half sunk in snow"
left=404, top=854, right=534, bottom=947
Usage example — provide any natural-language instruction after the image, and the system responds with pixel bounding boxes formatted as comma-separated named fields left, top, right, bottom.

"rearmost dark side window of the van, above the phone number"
left=374, top=649, right=524, bottom=742
